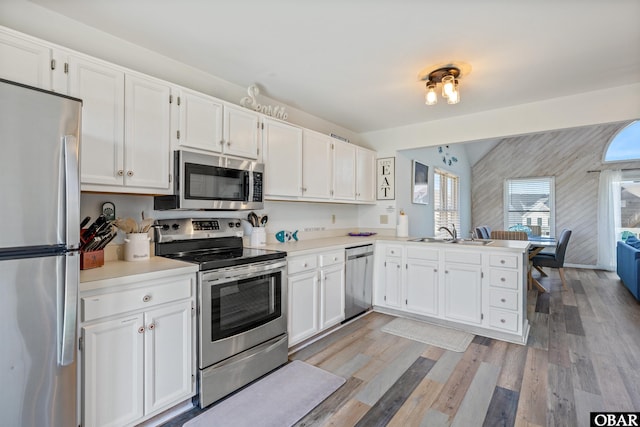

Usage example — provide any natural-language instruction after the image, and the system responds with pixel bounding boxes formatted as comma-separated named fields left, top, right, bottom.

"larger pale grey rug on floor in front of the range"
left=183, top=360, right=345, bottom=427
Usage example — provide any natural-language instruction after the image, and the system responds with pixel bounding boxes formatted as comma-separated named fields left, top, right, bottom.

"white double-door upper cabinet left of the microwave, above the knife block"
left=56, top=52, right=171, bottom=194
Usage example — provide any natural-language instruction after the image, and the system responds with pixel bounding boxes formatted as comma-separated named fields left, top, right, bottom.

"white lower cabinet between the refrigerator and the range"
left=80, top=274, right=195, bottom=427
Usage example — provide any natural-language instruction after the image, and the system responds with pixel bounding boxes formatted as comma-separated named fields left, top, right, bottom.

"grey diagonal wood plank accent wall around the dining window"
left=471, top=121, right=640, bottom=266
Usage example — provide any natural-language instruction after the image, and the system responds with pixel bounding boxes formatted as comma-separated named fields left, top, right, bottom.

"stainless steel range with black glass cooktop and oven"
left=155, top=218, right=288, bottom=408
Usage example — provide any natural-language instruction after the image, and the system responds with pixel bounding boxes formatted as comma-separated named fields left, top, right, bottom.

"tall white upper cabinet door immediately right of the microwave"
left=262, top=118, right=302, bottom=198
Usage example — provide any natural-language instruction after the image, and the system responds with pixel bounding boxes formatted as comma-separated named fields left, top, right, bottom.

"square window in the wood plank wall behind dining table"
left=504, top=177, right=555, bottom=237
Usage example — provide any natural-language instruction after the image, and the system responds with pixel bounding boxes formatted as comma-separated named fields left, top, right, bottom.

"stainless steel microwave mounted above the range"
left=153, top=150, right=264, bottom=210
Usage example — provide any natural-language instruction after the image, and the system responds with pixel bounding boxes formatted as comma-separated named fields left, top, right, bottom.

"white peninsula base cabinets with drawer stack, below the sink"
left=374, top=242, right=528, bottom=343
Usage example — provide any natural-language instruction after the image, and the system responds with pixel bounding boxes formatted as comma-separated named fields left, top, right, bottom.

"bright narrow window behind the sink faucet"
left=433, top=169, right=460, bottom=237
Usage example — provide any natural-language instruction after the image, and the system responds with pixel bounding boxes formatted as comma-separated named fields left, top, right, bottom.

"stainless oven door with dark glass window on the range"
left=198, top=260, right=287, bottom=369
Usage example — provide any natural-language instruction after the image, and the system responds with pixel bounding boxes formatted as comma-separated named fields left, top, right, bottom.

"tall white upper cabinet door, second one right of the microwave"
left=302, top=129, right=333, bottom=199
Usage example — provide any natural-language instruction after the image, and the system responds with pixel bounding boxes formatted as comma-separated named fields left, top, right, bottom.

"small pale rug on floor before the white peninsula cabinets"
left=382, top=317, right=474, bottom=353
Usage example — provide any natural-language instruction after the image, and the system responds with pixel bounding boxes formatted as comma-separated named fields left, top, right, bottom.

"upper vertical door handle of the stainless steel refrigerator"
left=64, top=135, right=80, bottom=249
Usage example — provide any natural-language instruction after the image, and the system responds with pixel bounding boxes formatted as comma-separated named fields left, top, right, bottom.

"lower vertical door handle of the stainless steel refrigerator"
left=58, top=252, right=80, bottom=366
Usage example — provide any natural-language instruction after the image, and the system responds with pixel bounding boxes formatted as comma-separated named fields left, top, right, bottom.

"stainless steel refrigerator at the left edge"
left=0, top=80, right=82, bottom=427
